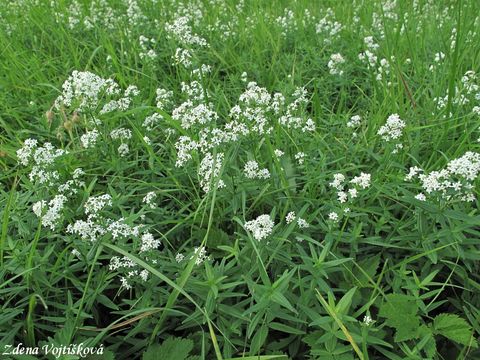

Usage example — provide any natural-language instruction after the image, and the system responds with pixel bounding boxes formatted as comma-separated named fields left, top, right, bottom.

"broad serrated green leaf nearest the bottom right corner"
left=433, top=314, right=478, bottom=348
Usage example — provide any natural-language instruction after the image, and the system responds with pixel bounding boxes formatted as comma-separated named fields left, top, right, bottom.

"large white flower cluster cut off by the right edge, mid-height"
left=405, top=151, right=480, bottom=201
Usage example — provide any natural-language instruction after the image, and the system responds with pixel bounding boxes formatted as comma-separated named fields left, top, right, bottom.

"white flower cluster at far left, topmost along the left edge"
left=17, top=139, right=66, bottom=184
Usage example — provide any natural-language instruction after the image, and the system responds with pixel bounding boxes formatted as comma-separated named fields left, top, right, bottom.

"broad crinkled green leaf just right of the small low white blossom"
left=378, top=294, right=420, bottom=342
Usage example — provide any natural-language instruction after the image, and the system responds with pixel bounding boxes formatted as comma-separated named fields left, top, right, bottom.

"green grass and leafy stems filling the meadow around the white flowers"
left=0, top=0, right=480, bottom=360
